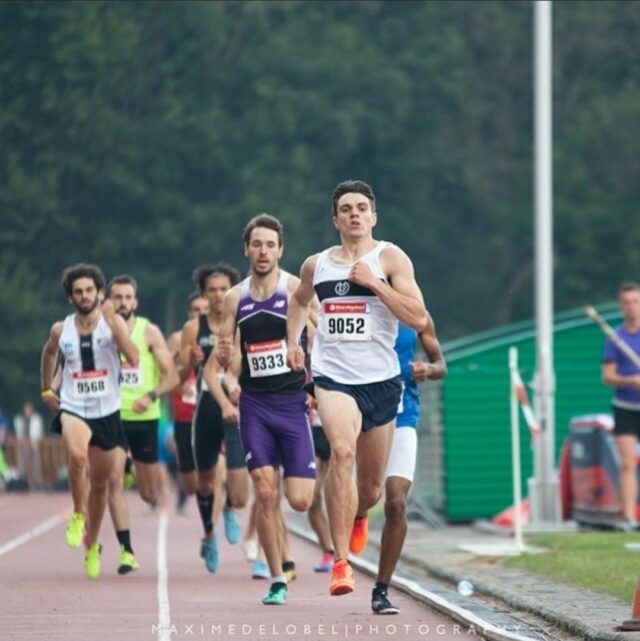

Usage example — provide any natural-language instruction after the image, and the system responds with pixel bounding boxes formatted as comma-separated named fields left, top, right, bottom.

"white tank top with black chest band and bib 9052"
left=311, top=241, right=400, bottom=385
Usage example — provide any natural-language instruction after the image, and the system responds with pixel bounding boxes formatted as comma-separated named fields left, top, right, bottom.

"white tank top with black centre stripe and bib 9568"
left=58, top=314, right=120, bottom=418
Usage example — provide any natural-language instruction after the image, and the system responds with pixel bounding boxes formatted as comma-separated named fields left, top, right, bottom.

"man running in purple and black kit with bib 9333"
left=215, top=214, right=316, bottom=605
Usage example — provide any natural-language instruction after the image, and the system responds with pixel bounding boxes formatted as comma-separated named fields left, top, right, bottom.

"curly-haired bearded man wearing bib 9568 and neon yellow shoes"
left=40, top=263, right=139, bottom=579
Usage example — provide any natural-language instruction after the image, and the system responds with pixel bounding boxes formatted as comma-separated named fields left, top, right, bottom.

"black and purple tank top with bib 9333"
left=236, top=271, right=305, bottom=392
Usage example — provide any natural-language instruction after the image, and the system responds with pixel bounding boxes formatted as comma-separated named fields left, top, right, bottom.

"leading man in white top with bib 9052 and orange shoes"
left=287, top=180, right=427, bottom=595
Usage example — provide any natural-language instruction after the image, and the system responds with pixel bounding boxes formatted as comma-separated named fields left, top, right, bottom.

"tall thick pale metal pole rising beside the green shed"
left=529, top=0, right=560, bottom=525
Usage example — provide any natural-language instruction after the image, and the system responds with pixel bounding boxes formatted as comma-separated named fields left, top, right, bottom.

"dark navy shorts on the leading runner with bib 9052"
left=313, top=376, right=402, bottom=432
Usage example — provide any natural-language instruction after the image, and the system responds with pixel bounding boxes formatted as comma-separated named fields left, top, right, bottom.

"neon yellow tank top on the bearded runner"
left=120, top=316, right=160, bottom=421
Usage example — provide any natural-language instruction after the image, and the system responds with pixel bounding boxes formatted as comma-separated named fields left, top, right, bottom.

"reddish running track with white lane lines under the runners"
left=0, top=493, right=480, bottom=641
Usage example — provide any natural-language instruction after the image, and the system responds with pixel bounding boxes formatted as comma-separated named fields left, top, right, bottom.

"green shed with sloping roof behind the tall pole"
left=412, top=303, right=621, bottom=522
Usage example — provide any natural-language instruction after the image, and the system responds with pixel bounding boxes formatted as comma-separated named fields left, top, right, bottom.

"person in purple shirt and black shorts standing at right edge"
left=602, top=282, right=640, bottom=530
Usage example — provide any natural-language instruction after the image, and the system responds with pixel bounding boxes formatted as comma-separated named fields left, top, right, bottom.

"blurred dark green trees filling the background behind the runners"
left=0, top=1, right=640, bottom=410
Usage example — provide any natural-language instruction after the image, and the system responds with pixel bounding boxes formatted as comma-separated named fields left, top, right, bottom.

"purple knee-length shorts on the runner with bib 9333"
left=238, top=390, right=316, bottom=479
